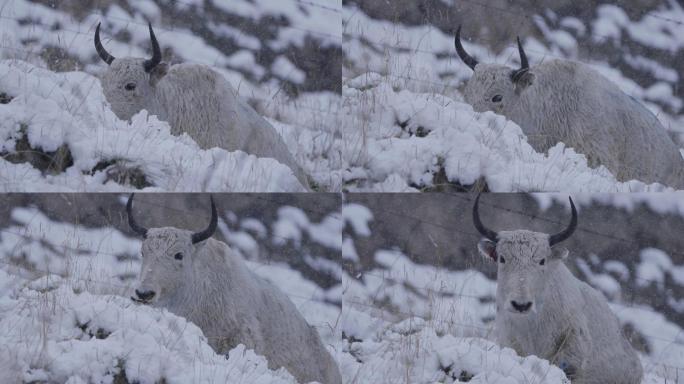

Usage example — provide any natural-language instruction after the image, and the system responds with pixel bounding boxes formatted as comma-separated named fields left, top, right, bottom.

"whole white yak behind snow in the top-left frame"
left=95, top=24, right=309, bottom=189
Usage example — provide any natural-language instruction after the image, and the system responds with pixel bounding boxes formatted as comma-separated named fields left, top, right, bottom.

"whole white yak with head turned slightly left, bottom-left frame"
left=126, top=195, right=342, bottom=384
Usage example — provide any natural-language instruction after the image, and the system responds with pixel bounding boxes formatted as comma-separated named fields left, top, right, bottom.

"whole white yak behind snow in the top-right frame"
left=455, top=27, right=684, bottom=189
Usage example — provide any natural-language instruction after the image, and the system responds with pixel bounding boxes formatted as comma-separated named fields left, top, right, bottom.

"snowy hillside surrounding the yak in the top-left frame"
left=0, top=0, right=341, bottom=192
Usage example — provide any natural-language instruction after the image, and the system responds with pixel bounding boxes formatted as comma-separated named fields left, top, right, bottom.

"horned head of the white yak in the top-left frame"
left=95, top=24, right=168, bottom=120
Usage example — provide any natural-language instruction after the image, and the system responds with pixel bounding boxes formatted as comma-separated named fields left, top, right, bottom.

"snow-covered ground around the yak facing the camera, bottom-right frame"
left=341, top=194, right=684, bottom=384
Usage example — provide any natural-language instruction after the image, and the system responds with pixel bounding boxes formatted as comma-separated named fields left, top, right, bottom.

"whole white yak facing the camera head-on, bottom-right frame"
left=473, top=195, right=643, bottom=384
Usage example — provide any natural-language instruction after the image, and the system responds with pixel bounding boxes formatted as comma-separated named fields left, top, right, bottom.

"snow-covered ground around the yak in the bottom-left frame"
left=0, top=200, right=342, bottom=384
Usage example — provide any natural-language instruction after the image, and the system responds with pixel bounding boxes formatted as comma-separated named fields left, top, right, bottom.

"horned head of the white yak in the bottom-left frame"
left=126, top=194, right=218, bottom=304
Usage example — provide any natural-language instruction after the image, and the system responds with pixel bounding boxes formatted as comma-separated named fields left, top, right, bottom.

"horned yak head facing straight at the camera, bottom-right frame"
left=473, top=195, right=577, bottom=315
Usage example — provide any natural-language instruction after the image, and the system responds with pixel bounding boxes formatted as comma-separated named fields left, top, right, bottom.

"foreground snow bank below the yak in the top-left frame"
left=0, top=61, right=305, bottom=192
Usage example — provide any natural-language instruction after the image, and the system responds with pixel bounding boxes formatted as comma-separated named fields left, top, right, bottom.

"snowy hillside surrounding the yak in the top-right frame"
left=342, top=0, right=684, bottom=192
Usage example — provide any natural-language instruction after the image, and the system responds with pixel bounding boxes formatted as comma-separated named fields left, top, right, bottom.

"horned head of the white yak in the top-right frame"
left=454, top=26, right=535, bottom=116
